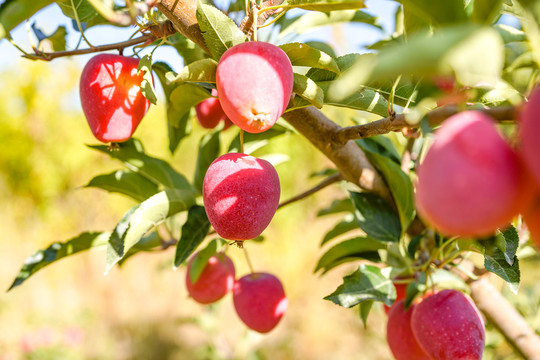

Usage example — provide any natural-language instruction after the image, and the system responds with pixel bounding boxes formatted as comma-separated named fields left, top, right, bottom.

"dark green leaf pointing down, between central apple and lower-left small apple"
left=174, top=205, right=210, bottom=269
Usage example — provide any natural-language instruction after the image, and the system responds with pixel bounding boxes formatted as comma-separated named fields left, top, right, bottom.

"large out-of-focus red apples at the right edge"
left=416, top=100, right=540, bottom=244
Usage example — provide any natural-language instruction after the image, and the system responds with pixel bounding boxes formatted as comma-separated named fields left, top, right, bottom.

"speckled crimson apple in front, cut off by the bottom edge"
left=411, top=290, right=485, bottom=360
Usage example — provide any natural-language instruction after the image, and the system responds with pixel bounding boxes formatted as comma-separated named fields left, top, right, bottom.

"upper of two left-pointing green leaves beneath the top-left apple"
left=89, top=144, right=193, bottom=190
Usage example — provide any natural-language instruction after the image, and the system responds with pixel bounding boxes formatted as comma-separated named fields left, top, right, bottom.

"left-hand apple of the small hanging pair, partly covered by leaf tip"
left=186, top=253, right=235, bottom=304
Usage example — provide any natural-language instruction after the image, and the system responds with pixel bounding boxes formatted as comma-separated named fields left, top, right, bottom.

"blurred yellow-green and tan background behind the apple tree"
left=0, top=59, right=540, bottom=360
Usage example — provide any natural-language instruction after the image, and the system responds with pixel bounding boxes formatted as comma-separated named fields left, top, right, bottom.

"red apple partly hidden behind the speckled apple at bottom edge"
left=386, top=300, right=431, bottom=360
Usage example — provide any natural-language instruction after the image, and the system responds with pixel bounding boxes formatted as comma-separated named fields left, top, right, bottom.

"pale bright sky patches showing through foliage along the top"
left=0, top=0, right=398, bottom=71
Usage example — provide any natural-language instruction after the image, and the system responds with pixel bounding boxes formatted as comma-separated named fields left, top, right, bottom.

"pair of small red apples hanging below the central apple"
left=186, top=252, right=288, bottom=333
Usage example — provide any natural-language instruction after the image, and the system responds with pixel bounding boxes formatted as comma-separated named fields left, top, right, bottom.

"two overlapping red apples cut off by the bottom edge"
left=386, top=289, right=485, bottom=360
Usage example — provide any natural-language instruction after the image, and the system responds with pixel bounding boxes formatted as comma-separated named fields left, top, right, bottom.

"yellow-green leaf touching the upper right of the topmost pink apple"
left=279, top=43, right=340, bottom=74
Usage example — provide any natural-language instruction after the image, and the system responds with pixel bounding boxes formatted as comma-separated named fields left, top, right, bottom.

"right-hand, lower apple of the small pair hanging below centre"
left=233, top=273, right=288, bottom=333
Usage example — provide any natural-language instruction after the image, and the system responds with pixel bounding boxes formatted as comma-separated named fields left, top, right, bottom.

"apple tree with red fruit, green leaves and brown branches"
left=0, top=0, right=540, bottom=359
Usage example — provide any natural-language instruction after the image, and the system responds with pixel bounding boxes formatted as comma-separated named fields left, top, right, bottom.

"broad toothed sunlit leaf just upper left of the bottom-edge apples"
left=324, top=265, right=396, bottom=308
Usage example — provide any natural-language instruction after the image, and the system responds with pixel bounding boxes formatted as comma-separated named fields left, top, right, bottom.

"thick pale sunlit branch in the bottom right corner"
left=470, top=276, right=540, bottom=360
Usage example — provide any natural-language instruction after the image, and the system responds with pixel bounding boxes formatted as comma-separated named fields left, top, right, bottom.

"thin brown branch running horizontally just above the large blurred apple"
left=332, top=105, right=516, bottom=144
